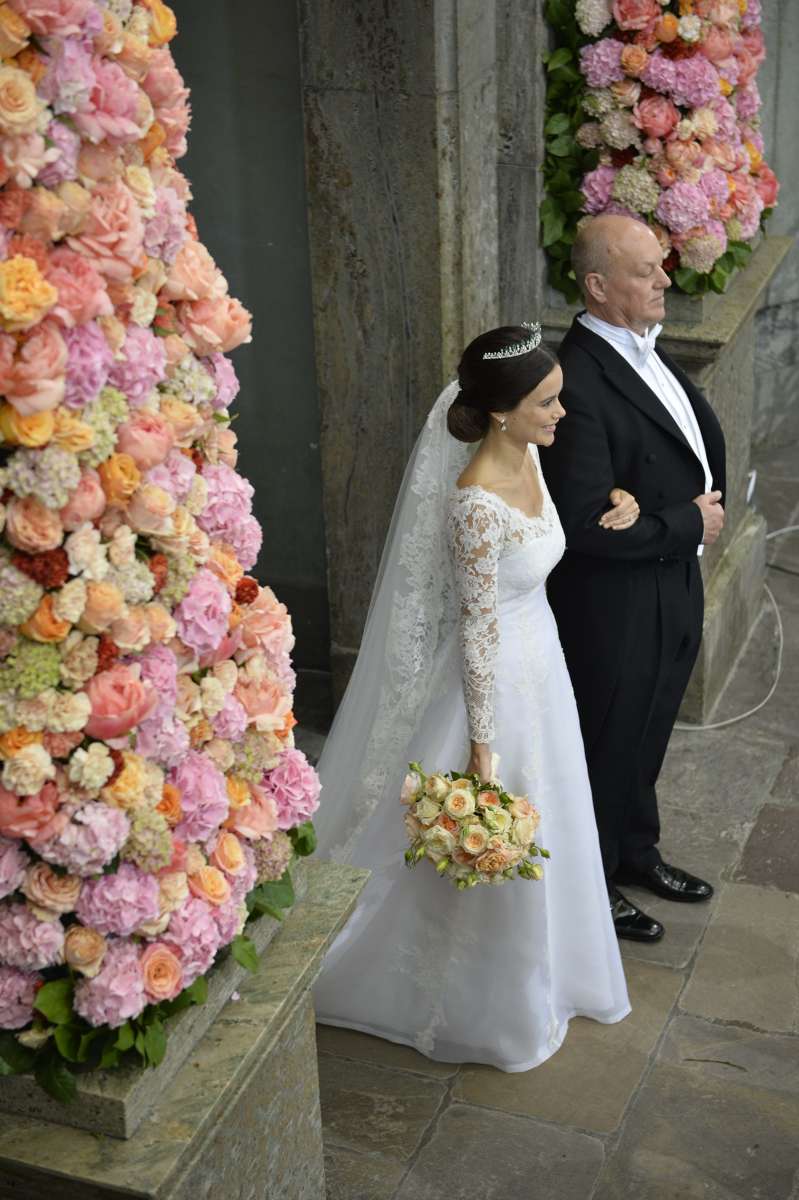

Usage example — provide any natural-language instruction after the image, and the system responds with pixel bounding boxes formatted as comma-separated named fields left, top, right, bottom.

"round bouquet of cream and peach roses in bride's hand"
left=400, top=762, right=549, bottom=890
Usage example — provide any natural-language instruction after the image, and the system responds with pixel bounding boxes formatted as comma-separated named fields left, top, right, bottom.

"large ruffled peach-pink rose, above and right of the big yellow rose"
left=67, top=180, right=144, bottom=283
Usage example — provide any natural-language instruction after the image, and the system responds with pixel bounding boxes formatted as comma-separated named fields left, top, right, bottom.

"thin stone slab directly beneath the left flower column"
left=0, top=859, right=308, bottom=1138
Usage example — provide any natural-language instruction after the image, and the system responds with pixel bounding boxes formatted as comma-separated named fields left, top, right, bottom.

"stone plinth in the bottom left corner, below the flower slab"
left=0, top=864, right=366, bottom=1200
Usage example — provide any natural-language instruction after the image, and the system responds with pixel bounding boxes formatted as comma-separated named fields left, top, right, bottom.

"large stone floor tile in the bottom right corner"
left=593, top=1018, right=799, bottom=1200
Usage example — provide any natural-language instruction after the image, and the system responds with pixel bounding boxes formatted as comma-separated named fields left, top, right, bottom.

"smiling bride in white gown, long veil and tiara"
left=314, top=325, right=638, bottom=1072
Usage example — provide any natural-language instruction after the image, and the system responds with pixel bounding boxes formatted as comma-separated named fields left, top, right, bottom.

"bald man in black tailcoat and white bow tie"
left=541, top=216, right=725, bottom=942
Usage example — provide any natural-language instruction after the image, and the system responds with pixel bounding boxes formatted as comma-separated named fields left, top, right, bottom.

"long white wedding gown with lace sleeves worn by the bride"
left=314, top=446, right=630, bottom=1072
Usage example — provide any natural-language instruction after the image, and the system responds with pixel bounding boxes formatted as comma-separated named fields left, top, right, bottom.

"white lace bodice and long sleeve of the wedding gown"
left=446, top=470, right=565, bottom=742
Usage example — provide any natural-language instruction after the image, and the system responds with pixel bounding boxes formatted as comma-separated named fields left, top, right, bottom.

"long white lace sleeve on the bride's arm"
left=447, top=496, right=504, bottom=742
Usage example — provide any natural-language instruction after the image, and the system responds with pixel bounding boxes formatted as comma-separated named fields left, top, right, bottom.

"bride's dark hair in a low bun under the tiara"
left=446, top=325, right=558, bottom=442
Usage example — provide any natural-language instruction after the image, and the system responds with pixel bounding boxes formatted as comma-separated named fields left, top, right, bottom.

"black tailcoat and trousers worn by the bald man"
left=541, top=320, right=725, bottom=875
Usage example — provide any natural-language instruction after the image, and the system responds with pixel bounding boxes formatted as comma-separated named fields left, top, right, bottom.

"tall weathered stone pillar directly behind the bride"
left=300, top=0, right=540, bottom=692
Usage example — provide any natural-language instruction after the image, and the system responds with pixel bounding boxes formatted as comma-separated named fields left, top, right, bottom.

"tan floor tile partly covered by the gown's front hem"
left=452, top=961, right=684, bottom=1133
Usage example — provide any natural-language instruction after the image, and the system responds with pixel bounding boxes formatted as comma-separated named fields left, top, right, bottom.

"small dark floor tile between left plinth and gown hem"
left=319, top=1055, right=446, bottom=1163
